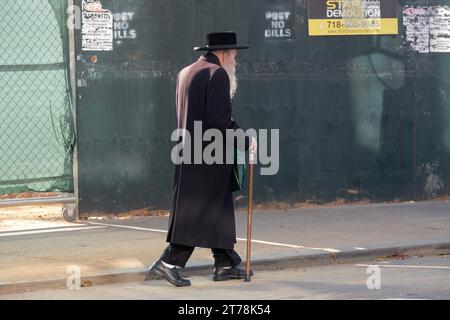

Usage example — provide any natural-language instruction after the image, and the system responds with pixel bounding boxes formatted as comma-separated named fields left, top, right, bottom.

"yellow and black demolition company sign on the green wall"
left=308, top=0, right=398, bottom=36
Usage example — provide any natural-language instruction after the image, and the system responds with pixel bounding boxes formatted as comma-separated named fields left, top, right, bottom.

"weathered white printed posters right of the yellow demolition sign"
left=403, top=6, right=450, bottom=53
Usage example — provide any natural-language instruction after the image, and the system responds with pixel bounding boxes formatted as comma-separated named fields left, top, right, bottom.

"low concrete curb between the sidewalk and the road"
left=0, top=242, right=450, bottom=296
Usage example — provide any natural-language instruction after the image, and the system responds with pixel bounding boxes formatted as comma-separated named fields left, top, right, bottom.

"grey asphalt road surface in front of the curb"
left=4, top=255, right=450, bottom=300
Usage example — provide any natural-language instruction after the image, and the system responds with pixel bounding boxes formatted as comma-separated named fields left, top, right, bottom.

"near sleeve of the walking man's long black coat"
left=206, top=68, right=250, bottom=150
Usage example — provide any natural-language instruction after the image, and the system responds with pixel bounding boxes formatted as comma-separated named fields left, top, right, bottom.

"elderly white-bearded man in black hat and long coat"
left=147, top=32, right=256, bottom=286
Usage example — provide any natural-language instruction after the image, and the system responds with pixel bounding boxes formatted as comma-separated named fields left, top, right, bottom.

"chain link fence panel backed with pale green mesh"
left=0, top=0, right=75, bottom=195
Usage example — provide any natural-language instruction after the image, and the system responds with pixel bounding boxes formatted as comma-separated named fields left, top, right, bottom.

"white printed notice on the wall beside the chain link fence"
left=81, top=0, right=113, bottom=51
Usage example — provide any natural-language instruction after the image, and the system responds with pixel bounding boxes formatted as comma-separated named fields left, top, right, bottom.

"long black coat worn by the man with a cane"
left=167, top=53, right=248, bottom=249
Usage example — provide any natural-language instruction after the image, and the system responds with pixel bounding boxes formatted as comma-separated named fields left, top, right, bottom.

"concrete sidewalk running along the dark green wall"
left=0, top=201, right=450, bottom=294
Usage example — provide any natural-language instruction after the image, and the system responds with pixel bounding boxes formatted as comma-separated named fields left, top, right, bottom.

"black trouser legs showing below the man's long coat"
left=161, top=243, right=241, bottom=268
